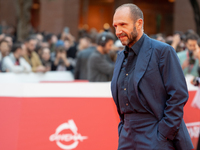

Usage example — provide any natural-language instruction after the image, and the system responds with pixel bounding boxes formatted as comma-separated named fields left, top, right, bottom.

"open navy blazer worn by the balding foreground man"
left=111, top=35, right=193, bottom=150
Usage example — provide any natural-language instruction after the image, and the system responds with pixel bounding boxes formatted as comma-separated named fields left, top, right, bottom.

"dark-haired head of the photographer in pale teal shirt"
left=186, top=33, right=199, bottom=51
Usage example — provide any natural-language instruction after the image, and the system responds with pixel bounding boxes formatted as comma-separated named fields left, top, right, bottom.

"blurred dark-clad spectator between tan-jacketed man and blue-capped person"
left=41, top=47, right=52, bottom=71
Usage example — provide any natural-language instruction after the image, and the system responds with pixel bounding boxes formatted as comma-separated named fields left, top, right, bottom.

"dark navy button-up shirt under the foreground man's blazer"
left=117, top=34, right=147, bottom=114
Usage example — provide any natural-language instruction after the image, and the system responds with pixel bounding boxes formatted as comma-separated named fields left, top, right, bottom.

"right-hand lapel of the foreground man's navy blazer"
left=134, top=35, right=152, bottom=99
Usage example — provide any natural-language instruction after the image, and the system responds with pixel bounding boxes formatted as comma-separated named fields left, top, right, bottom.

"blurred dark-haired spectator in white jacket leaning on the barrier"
left=2, top=43, right=31, bottom=73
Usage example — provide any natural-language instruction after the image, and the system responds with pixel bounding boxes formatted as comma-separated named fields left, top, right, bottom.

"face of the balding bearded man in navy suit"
left=113, top=7, right=138, bottom=46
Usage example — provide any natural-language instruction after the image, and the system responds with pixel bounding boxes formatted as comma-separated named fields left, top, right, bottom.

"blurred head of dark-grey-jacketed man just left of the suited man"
left=96, top=32, right=115, bottom=54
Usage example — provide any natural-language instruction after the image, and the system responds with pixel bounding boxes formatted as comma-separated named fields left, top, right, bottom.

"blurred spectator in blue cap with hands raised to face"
left=52, top=40, right=72, bottom=71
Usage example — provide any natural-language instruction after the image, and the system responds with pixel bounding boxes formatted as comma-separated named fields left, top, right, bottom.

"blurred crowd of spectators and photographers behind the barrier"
left=0, top=24, right=200, bottom=84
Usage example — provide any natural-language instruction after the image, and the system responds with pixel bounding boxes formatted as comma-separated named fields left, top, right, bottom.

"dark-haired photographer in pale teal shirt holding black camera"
left=177, top=33, right=199, bottom=77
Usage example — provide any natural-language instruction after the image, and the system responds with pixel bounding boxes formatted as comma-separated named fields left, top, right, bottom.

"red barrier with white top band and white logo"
left=0, top=73, right=200, bottom=150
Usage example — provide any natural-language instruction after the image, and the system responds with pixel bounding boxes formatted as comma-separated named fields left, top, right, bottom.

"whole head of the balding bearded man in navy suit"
left=113, top=4, right=144, bottom=47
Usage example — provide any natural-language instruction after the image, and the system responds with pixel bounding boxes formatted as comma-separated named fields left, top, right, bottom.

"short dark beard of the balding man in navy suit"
left=118, top=27, right=138, bottom=46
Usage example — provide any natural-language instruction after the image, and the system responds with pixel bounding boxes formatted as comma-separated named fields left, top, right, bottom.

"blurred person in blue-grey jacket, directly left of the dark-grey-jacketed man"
left=74, top=34, right=97, bottom=80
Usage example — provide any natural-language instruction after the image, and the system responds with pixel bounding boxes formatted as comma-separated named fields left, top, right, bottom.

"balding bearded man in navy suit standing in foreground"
left=111, top=4, right=193, bottom=150
